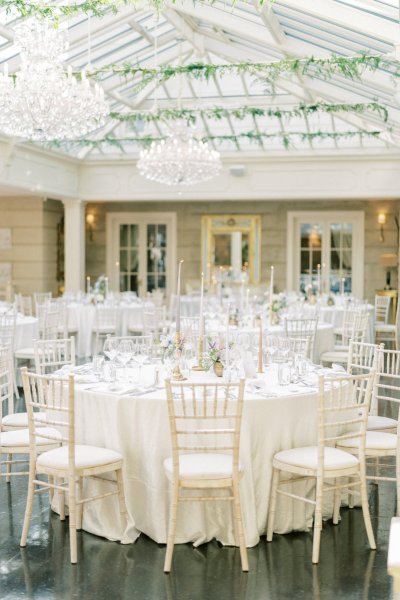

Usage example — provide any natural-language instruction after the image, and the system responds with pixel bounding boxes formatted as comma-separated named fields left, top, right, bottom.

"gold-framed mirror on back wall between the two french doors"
left=201, top=215, right=261, bottom=284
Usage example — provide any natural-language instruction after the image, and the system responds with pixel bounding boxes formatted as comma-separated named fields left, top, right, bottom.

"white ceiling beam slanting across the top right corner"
left=275, top=0, right=399, bottom=44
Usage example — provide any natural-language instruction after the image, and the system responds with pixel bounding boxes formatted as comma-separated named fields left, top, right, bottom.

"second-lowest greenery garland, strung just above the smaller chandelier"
left=110, top=102, right=389, bottom=124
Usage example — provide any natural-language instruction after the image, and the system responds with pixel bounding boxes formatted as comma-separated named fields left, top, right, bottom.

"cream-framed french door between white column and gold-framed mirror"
left=106, top=213, right=176, bottom=296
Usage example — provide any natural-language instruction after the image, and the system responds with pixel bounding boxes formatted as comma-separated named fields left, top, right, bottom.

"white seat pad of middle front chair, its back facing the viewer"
left=164, top=452, right=243, bottom=479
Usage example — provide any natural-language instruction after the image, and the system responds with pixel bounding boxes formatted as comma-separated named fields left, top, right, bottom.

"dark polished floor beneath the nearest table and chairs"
left=0, top=466, right=395, bottom=600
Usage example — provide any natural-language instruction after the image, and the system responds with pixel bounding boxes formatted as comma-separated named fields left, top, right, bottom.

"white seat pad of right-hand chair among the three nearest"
left=273, top=446, right=358, bottom=471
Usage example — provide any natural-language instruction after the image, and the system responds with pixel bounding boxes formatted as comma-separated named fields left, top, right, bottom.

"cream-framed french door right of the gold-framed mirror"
left=287, top=211, right=364, bottom=298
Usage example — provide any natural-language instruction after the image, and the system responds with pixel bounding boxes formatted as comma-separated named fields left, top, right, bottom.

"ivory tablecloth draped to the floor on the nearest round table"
left=72, top=375, right=318, bottom=547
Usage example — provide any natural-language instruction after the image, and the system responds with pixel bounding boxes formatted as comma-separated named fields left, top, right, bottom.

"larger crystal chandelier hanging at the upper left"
left=0, top=19, right=109, bottom=141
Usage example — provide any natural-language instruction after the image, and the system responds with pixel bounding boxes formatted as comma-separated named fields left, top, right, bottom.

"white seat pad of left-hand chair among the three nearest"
left=37, top=445, right=122, bottom=470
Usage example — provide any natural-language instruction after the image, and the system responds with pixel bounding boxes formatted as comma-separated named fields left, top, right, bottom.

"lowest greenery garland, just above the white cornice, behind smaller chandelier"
left=48, top=129, right=383, bottom=150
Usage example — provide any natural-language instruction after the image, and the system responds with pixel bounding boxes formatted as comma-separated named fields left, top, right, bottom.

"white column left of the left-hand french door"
left=63, top=199, right=85, bottom=292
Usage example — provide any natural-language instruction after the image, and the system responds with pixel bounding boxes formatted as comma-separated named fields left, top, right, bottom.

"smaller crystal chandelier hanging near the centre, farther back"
left=137, top=123, right=222, bottom=185
